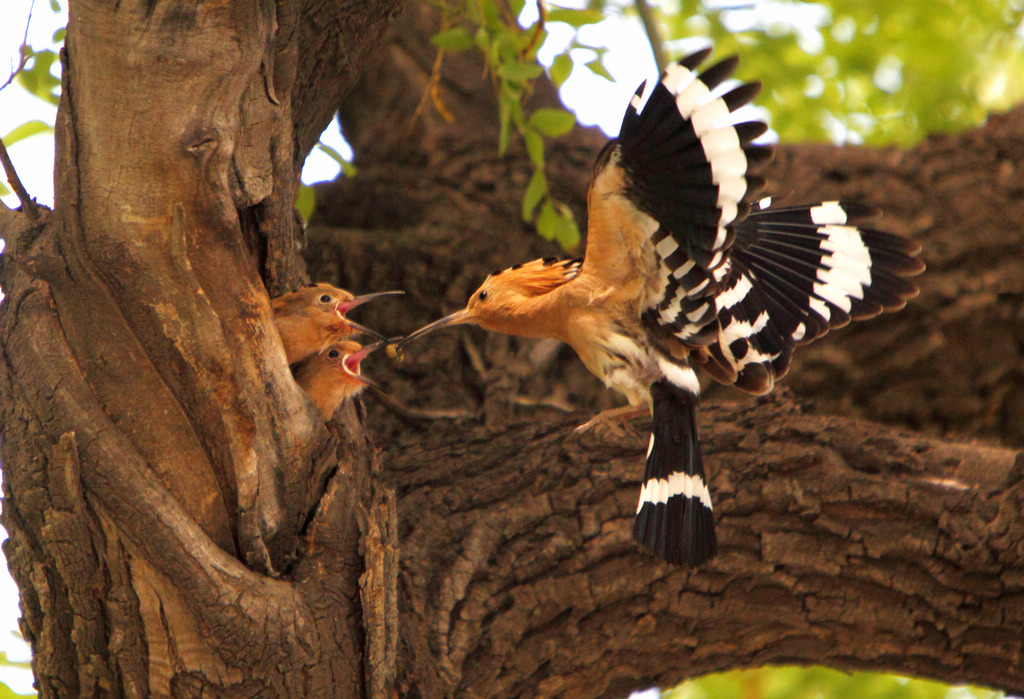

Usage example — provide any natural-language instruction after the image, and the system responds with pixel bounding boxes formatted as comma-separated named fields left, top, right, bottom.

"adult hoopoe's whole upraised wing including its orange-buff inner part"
left=583, top=49, right=771, bottom=346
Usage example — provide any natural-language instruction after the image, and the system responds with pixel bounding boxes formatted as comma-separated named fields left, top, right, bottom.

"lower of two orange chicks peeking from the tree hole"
left=295, top=340, right=383, bottom=420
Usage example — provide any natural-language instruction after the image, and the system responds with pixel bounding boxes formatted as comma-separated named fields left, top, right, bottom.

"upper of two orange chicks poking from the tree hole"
left=270, top=282, right=402, bottom=364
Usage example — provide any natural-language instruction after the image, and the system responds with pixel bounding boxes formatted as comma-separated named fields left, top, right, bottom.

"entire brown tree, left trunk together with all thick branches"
left=0, top=1, right=1024, bottom=697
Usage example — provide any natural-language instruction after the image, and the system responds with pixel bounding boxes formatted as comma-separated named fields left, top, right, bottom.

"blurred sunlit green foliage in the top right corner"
left=662, top=0, right=1024, bottom=145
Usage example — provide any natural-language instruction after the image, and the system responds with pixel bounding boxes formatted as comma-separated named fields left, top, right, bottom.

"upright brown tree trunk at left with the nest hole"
left=0, top=1, right=396, bottom=697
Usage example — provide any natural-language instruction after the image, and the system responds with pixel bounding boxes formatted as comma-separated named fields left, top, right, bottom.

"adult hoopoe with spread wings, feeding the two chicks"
left=403, top=49, right=924, bottom=566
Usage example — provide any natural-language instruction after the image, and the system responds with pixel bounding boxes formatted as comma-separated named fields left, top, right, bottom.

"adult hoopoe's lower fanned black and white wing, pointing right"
left=708, top=200, right=925, bottom=393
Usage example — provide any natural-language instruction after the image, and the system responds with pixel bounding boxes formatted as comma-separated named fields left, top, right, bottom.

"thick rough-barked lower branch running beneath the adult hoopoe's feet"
left=388, top=400, right=1024, bottom=696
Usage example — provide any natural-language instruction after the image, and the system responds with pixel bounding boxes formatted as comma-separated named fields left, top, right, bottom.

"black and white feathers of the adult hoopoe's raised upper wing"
left=616, top=49, right=771, bottom=345
